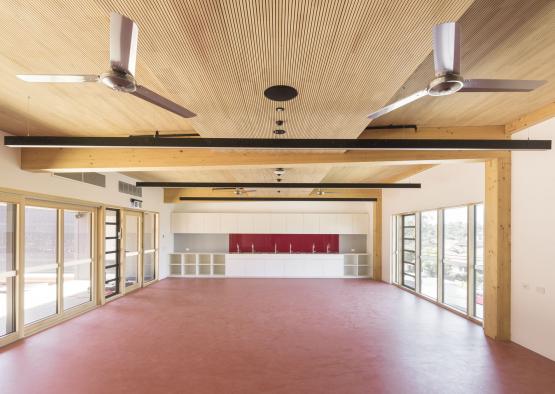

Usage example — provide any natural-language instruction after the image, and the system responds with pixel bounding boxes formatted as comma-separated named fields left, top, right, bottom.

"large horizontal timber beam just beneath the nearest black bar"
left=21, top=148, right=506, bottom=172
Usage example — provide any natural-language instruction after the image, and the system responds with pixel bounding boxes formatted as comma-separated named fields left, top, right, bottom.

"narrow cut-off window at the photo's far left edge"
left=0, top=202, right=17, bottom=337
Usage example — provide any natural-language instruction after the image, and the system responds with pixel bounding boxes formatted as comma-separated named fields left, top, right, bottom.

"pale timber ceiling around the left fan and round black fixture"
left=0, top=0, right=472, bottom=138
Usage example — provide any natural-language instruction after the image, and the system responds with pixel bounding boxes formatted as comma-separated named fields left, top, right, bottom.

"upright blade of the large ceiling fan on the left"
left=110, top=12, right=139, bottom=75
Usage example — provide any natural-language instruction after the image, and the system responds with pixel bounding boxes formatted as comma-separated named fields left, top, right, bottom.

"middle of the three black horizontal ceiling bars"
left=135, top=182, right=422, bottom=189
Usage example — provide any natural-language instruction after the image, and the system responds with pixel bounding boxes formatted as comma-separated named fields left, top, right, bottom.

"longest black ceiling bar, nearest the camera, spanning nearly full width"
left=4, top=136, right=551, bottom=150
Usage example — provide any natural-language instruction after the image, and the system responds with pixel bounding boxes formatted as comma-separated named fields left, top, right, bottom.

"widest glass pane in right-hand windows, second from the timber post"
left=443, top=207, right=468, bottom=311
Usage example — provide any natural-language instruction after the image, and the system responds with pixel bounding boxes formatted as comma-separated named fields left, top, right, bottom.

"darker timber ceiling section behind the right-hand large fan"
left=372, top=0, right=555, bottom=126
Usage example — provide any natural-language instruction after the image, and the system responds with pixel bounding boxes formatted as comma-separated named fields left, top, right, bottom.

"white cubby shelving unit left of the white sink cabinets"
left=170, top=253, right=225, bottom=277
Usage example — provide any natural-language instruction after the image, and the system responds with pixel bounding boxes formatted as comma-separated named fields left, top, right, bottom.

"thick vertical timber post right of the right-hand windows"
left=484, top=153, right=511, bottom=341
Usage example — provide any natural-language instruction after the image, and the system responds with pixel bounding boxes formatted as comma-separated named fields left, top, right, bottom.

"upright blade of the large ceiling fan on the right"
left=433, top=22, right=461, bottom=76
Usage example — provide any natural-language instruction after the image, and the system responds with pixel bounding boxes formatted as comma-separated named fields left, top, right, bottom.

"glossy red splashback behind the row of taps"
left=229, top=234, right=339, bottom=253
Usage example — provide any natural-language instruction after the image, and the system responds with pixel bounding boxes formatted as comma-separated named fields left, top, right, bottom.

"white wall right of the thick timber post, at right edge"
left=511, top=118, right=555, bottom=360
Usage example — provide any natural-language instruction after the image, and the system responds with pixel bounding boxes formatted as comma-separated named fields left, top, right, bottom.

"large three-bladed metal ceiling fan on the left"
left=17, top=12, right=196, bottom=118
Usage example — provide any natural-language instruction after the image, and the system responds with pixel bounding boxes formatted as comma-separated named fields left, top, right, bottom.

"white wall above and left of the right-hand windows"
left=382, top=163, right=485, bottom=282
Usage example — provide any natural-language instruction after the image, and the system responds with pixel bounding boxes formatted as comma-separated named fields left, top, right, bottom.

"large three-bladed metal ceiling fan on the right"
left=368, top=22, right=546, bottom=119
